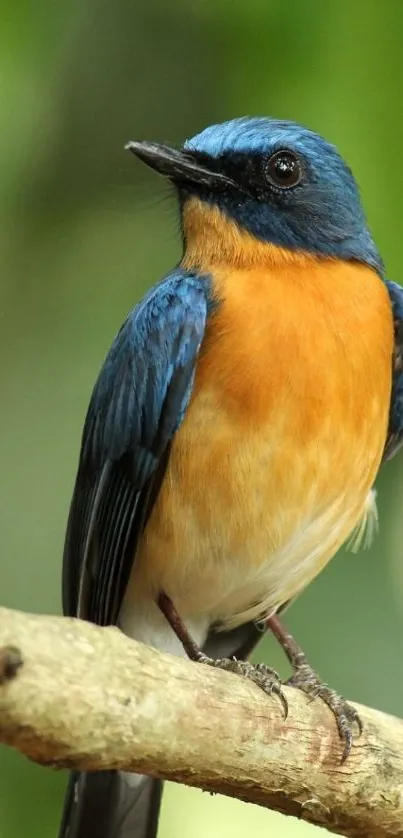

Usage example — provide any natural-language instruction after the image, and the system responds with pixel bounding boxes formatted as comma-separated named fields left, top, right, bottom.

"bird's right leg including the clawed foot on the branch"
left=266, top=616, right=362, bottom=762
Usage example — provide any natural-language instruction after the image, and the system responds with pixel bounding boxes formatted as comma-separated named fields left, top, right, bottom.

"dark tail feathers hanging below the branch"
left=59, top=771, right=162, bottom=838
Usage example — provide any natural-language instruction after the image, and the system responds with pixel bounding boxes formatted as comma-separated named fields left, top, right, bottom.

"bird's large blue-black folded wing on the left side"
left=63, top=269, right=209, bottom=625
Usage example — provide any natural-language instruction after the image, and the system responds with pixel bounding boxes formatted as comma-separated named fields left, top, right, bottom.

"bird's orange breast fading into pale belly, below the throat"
left=124, top=207, right=393, bottom=626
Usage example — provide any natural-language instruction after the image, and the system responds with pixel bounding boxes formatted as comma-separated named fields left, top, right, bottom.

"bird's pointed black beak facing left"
left=125, top=141, right=234, bottom=189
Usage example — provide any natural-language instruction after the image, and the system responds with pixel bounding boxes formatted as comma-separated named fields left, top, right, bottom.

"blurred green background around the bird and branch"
left=0, top=0, right=403, bottom=838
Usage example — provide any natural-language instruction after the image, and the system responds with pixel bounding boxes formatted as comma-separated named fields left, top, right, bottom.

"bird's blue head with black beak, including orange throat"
left=127, top=117, right=383, bottom=273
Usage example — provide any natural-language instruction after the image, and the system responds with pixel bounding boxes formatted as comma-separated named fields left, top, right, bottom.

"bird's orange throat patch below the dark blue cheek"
left=181, top=198, right=315, bottom=272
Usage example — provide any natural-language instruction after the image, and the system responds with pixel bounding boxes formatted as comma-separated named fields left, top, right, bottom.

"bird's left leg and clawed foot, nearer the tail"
left=157, top=592, right=288, bottom=719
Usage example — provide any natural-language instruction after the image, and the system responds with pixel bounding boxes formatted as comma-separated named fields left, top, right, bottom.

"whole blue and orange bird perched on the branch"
left=59, top=118, right=403, bottom=838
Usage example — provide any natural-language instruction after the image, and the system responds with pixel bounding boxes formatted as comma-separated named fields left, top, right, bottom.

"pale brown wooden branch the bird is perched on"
left=0, top=609, right=403, bottom=838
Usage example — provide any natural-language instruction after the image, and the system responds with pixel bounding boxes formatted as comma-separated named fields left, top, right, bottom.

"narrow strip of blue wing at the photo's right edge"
left=383, top=281, right=403, bottom=461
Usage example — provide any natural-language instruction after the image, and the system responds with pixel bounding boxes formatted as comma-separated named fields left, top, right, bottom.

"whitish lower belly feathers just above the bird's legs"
left=119, top=491, right=377, bottom=655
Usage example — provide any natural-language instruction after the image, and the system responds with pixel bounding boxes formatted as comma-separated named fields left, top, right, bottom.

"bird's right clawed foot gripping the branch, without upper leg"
left=285, top=659, right=363, bottom=763
